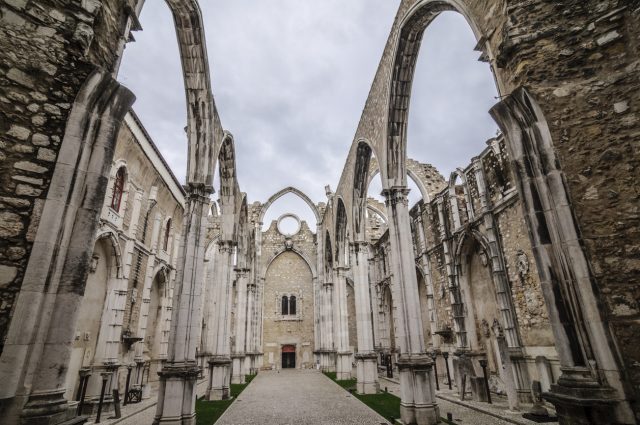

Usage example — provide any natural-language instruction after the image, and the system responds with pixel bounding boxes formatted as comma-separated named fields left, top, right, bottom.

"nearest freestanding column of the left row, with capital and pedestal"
left=153, top=184, right=212, bottom=425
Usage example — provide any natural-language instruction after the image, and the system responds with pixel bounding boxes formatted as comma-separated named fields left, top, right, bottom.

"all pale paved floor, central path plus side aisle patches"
left=81, top=370, right=560, bottom=425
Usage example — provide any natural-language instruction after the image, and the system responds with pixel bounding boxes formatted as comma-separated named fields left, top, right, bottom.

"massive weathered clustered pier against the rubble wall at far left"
left=0, top=71, right=135, bottom=425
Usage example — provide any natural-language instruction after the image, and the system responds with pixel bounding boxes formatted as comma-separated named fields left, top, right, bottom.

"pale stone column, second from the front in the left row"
left=206, top=241, right=235, bottom=400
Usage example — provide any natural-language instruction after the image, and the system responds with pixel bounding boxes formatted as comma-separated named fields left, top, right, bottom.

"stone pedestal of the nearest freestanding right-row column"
left=397, top=354, right=440, bottom=425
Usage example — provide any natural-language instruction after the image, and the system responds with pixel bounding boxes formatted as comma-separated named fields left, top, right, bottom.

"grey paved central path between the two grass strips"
left=216, top=369, right=388, bottom=425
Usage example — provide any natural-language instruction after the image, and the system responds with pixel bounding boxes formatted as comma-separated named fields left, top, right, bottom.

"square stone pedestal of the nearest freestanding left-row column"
left=153, top=362, right=200, bottom=425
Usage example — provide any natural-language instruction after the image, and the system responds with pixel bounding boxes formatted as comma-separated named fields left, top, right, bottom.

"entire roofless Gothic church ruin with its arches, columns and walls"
left=0, top=0, right=640, bottom=425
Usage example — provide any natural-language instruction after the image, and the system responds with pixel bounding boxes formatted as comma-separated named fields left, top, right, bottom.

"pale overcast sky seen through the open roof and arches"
left=119, top=0, right=496, bottom=228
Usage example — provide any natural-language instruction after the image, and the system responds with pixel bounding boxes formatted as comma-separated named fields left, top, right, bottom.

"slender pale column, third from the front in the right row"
left=333, top=267, right=352, bottom=380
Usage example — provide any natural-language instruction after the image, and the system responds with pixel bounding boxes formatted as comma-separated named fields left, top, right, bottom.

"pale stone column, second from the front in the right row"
left=351, top=241, right=380, bottom=394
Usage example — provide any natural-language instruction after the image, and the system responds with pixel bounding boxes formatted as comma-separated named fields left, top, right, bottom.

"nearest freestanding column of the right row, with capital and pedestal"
left=383, top=187, right=440, bottom=425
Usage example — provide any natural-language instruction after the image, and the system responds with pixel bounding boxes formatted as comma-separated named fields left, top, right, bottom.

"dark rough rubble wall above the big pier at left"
left=0, top=0, right=131, bottom=353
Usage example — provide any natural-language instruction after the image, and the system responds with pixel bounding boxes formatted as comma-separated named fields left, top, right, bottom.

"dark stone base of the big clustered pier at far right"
left=542, top=369, right=634, bottom=425
